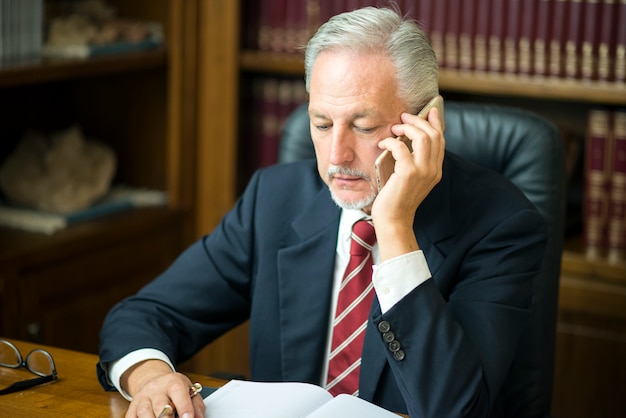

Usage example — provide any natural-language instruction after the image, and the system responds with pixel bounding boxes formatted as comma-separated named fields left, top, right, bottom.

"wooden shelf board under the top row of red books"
left=239, top=51, right=626, bottom=105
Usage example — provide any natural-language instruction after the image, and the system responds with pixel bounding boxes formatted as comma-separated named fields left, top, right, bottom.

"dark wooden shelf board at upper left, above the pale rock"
left=0, top=48, right=166, bottom=88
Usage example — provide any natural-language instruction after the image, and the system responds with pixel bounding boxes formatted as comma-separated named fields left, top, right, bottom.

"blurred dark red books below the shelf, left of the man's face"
left=239, top=76, right=307, bottom=184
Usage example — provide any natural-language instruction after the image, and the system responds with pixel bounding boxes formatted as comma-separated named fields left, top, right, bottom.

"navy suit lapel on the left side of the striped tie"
left=278, top=187, right=341, bottom=383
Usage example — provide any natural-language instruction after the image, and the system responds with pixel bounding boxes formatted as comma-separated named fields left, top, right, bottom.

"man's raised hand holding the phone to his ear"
left=372, top=108, right=445, bottom=261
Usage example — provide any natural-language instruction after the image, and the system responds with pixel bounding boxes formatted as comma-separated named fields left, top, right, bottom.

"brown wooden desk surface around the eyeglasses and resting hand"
left=0, top=340, right=223, bottom=418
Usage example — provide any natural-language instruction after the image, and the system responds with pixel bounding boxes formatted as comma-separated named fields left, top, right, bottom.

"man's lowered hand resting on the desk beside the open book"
left=121, top=360, right=204, bottom=418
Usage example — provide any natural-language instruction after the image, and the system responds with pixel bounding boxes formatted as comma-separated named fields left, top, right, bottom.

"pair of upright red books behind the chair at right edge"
left=583, top=108, right=626, bottom=263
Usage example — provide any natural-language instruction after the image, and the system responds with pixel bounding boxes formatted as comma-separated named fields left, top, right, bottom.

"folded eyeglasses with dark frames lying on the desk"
left=0, top=340, right=57, bottom=395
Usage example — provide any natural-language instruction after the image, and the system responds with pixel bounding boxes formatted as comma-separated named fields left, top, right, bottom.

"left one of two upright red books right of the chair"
left=584, top=108, right=611, bottom=259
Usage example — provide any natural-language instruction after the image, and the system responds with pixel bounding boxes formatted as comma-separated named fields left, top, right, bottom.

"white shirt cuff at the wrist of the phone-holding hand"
left=372, top=250, right=431, bottom=314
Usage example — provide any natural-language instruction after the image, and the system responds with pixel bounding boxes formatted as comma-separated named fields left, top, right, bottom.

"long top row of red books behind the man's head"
left=242, top=0, right=626, bottom=83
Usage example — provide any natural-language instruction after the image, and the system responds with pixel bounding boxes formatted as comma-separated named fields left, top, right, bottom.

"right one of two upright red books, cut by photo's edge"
left=607, top=109, right=626, bottom=263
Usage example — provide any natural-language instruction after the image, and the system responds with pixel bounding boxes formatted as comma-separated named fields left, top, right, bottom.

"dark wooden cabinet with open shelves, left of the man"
left=0, top=0, right=202, bottom=352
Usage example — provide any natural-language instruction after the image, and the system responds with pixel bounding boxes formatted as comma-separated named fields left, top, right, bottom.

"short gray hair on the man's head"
left=304, top=7, right=439, bottom=113
